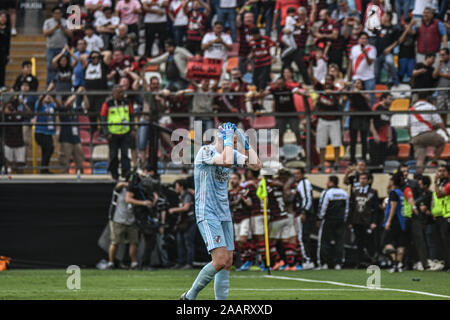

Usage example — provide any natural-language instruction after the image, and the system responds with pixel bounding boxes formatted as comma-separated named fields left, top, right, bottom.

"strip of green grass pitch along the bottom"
left=0, top=269, right=450, bottom=300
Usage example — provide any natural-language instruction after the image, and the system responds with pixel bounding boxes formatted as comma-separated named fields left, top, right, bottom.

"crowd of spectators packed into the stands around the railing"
left=0, top=0, right=450, bottom=174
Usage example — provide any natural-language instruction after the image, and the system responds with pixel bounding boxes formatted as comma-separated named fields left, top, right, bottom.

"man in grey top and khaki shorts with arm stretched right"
left=106, top=182, right=140, bottom=269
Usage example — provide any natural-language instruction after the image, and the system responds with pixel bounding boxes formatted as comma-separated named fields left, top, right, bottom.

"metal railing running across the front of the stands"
left=0, top=88, right=450, bottom=173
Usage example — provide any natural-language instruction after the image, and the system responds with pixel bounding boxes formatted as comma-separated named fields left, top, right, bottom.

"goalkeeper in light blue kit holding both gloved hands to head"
left=181, top=122, right=261, bottom=300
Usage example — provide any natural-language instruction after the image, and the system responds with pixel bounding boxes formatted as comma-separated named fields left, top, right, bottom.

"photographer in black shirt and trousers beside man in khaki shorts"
left=125, top=169, right=159, bottom=268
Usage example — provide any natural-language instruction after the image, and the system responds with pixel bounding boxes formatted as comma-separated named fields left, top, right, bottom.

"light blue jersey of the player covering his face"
left=194, top=145, right=245, bottom=223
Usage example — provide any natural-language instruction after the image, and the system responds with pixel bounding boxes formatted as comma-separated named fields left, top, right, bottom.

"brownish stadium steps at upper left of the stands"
left=6, top=35, right=47, bottom=90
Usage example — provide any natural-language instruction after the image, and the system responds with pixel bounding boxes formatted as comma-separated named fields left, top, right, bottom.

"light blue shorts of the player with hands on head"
left=197, top=220, right=234, bottom=252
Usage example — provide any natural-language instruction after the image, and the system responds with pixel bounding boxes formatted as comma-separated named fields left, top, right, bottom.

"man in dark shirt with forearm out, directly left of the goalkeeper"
left=169, top=180, right=196, bottom=269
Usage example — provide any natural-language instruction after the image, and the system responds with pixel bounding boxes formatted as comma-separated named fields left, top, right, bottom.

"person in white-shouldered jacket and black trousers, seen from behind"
left=316, top=176, right=349, bottom=270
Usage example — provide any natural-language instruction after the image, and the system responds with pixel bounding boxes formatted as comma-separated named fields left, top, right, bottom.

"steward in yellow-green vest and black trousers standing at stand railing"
left=100, top=85, right=135, bottom=180
